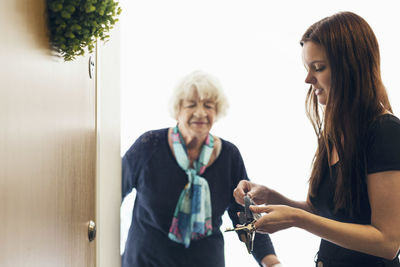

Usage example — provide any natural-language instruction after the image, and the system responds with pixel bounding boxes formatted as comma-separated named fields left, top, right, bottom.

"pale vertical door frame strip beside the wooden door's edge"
left=96, top=25, right=121, bottom=267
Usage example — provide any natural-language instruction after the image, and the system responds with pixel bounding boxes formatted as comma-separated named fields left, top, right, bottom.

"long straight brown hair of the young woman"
left=300, top=12, right=392, bottom=215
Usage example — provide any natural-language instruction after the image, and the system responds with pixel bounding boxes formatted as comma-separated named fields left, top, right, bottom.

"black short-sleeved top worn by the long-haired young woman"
left=310, top=114, right=400, bottom=267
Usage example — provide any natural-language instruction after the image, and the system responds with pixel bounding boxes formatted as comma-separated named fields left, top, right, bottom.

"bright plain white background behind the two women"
left=120, top=0, right=400, bottom=267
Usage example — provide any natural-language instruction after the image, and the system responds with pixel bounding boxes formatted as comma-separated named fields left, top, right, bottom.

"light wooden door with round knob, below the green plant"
left=0, top=0, right=96, bottom=267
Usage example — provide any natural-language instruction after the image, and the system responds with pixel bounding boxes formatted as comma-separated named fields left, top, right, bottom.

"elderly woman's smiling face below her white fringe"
left=178, top=92, right=217, bottom=139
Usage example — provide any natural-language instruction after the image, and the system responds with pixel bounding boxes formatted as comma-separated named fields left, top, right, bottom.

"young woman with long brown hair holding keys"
left=234, top=12, right=400, bottom=267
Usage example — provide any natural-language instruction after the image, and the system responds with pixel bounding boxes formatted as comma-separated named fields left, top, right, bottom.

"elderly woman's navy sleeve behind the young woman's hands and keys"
left=228, top=146, right=275, bottom=266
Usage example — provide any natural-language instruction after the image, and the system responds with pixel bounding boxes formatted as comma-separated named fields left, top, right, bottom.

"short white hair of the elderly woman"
left=169, top=71, right=229, bottom=119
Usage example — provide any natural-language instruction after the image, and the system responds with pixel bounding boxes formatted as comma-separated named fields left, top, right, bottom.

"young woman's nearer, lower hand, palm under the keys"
left=250, top=205, right=302, bottom=233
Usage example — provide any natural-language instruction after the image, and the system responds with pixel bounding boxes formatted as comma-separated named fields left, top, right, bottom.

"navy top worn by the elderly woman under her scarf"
left=122, top=129, right=275, bottom=267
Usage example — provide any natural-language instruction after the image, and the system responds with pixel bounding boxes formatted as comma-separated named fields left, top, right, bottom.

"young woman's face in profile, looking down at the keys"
left=303, top=41, right=331, bottom=105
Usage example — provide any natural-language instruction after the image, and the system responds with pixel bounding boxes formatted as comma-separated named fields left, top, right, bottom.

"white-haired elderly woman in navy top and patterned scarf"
left=122, top=71, right=279, bottom=267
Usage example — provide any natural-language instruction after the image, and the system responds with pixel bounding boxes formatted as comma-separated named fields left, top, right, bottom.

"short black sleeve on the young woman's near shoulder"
left=366, top=116, right=400, bottom=174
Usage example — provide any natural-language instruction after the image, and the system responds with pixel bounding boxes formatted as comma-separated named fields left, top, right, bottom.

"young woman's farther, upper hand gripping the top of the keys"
left=233, top=180, right=271, bottom=205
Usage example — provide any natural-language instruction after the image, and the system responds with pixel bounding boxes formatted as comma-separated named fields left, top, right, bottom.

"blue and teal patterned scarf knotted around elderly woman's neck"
left=168, top=126, right=214, bottom=248
